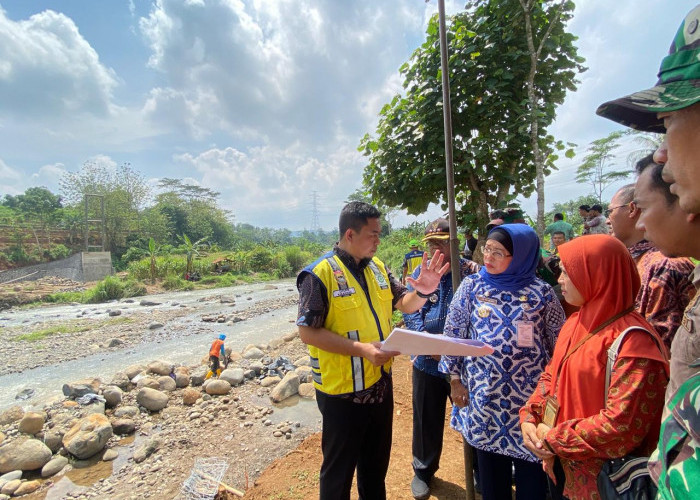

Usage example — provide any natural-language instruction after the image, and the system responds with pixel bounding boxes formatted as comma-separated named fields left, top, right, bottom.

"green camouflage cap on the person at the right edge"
left=596, top=5, right=700, bottom=133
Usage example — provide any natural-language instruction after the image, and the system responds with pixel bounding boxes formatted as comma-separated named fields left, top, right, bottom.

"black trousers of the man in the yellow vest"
left=316, top=381, right=394, bottom=500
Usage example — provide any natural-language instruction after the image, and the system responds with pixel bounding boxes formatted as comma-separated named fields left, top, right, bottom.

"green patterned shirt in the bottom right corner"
left=649, top=373, right=700, bottom=500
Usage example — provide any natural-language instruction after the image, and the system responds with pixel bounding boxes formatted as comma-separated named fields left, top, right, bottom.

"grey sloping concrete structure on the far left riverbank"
left=0, top=252, right=114, bottom=283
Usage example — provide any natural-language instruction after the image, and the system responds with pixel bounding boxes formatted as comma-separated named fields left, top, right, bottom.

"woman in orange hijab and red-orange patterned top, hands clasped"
left=520, top=235, right=668, bottom=500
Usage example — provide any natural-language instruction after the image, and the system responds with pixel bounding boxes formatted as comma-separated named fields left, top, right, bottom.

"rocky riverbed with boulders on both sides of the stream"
left=0, top=285, right=320, bottom=500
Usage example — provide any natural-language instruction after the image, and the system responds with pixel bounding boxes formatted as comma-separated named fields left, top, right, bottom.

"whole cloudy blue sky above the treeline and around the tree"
left=0, top=0, right=695, bottom=230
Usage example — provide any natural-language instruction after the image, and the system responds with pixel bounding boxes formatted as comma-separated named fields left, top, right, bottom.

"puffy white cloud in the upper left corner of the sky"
left=0, top=9, right=117, bottom=121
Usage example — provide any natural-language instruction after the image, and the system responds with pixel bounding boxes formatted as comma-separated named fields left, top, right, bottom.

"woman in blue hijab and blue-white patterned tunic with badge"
left=440, top=224, right=566, bottom=500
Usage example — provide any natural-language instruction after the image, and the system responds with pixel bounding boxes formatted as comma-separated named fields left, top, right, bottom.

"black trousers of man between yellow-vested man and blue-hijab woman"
left=413, top=367, right=450, bottom=482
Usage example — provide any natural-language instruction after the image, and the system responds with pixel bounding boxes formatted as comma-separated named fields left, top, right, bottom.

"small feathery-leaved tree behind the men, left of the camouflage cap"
left=576, top=131, right=632, bottom=203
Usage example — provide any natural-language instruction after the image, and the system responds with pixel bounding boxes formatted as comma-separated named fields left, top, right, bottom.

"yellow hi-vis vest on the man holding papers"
left=307, top=254, right=393, bottom=394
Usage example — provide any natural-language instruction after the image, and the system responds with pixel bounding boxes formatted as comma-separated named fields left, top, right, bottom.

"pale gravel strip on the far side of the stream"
left=0, top=285, right=297, bottom=375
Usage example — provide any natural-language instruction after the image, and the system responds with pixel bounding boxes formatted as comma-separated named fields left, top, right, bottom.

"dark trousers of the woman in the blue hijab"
left=476, top=449, right=547, bottom=500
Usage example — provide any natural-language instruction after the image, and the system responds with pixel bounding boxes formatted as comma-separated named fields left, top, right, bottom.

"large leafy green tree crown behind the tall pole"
left=360, top=0, right=579, bottom=233
